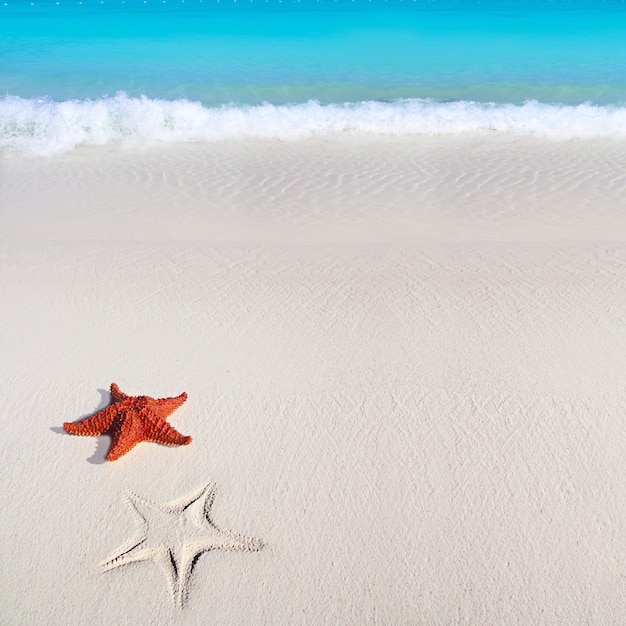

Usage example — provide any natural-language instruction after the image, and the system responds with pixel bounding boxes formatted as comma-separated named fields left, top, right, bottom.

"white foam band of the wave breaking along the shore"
left=0, top=93, right=626, bottom=156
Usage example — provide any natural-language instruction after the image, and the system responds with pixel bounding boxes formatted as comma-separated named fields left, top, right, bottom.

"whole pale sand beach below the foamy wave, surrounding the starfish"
left=0, top=134, right=626, bottom=625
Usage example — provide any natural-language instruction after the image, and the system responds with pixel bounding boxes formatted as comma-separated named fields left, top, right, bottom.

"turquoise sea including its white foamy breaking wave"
left=0, top=0, right=626, bottom=154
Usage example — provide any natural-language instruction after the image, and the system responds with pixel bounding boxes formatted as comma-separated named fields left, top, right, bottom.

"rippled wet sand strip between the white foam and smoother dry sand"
left=0, top=135, right=626, bottom=244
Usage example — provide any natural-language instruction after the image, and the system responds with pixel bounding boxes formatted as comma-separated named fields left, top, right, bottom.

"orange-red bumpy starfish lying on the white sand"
left=63, top=383, right=191, bottom=461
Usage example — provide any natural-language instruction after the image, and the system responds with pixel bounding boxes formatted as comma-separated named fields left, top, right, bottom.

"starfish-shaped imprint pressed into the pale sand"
left=100, top=483, right=263, bottom=607
